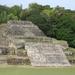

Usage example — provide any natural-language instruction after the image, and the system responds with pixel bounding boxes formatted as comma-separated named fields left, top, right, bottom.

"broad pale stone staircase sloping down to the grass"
left=25, top=42, right=70, bottom=66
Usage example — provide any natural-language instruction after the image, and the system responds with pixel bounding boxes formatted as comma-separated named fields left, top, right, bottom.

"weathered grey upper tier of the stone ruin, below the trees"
left=6, top=21, right=44, bottom=37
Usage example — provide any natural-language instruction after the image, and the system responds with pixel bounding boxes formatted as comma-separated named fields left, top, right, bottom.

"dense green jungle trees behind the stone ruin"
left=0, top=3, right=75, bottom=48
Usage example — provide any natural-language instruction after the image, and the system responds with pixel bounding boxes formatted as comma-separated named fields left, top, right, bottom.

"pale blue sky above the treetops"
left=0, top=0, right=75, bottom=10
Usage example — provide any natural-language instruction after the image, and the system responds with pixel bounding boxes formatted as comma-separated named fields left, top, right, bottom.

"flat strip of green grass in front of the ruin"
left=0, top=67, right=75, bottom=75
